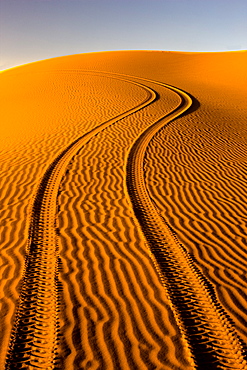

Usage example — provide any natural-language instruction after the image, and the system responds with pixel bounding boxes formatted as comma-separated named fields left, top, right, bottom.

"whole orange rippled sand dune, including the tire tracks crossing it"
left=0, top=51, right=247, bottom=370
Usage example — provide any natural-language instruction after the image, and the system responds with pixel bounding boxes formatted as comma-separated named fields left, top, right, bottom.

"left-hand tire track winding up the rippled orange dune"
left=6, top=77, right=157, bottom=370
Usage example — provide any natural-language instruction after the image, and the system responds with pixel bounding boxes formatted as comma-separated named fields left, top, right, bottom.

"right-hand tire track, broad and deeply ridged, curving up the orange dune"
left=126, top=76, right=247, bottom=369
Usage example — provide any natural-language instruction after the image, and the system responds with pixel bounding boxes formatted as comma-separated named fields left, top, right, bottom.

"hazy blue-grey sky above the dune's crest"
left=0, top=0, right=247, bottom=70
